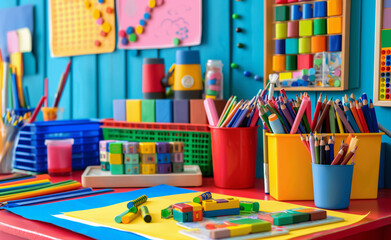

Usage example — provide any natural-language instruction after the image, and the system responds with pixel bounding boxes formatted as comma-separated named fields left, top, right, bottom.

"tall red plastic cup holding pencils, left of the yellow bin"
left=210, top=127, right=258, bottom=188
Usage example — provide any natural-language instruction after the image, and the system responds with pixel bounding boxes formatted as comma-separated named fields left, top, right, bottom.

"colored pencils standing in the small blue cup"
left=300, top=132, right=358, bottom=165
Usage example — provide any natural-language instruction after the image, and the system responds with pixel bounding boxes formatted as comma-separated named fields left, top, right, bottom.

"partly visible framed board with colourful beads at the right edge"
left=373, top=0, right=391, bottom=106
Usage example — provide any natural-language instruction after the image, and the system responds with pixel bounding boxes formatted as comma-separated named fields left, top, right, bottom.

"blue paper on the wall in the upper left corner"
left=0, top=5, right=34, bottom=59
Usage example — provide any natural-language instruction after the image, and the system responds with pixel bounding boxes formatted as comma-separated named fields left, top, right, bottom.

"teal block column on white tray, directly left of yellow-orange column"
left=122, top=142, right=140, bottom=174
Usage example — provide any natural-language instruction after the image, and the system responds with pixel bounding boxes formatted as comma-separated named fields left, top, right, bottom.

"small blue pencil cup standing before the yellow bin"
left=312, top=163, right=354, bottom=209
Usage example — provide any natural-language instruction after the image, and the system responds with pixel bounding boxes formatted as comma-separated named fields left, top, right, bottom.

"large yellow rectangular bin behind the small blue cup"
left=266, top=133, right=384, bottom=200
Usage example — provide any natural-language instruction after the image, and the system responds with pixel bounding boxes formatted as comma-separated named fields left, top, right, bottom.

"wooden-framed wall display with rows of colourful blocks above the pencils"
left=264, top=0, right=350, bottom=91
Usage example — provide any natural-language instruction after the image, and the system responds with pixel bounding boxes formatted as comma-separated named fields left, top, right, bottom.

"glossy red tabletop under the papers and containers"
left=0, top=171, right=391, bottom=240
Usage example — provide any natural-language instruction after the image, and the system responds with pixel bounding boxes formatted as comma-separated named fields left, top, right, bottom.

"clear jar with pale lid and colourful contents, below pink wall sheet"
left=205, top=60, right=223, bottom=99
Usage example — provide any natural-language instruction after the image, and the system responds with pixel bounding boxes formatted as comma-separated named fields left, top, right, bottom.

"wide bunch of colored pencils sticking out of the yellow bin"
left=257, top=89, right=379, bottom=134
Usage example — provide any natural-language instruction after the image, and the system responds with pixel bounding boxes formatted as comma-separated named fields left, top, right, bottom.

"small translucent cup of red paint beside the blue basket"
left=45, top=138, right=73, bottom=175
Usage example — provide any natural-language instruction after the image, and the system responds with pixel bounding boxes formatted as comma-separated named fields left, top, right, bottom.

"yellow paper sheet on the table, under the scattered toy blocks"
left=64, top=192, right=366, bottom=239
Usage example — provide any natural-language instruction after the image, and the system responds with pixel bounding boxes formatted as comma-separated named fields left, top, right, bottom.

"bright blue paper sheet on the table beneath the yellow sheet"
left=7, top=185, right=195, bottom=239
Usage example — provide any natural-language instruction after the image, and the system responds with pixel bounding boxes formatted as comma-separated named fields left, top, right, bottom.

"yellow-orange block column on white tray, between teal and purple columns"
left=139, top=142, right=157, bottom=174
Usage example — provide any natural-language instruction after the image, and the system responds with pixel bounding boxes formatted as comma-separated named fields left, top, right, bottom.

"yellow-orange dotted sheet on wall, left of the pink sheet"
left=49, top=0, right=115, bottom=57
